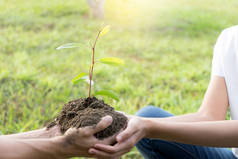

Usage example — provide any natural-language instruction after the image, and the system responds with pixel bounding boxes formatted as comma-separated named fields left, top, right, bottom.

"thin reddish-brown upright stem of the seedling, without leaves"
left=88, top=30, right=101, bottom=102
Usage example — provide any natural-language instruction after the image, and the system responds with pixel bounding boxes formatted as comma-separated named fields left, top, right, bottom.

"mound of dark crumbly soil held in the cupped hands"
left=47, top=97, right=127, bottom=140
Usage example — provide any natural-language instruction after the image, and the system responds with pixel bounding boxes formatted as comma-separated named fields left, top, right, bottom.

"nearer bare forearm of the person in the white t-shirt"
left=145, top=119, right=238, bottom=147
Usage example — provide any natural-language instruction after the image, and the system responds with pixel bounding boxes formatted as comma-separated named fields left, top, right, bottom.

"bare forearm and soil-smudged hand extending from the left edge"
left=0, top=116, right=115, bottom=159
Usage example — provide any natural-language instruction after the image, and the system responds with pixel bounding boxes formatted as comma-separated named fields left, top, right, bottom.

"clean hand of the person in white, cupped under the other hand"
left=89, top=116, right=146, bottom=159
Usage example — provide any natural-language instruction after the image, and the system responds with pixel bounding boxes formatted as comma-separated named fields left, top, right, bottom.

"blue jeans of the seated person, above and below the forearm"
left=136, top=106, right=237, bottom=159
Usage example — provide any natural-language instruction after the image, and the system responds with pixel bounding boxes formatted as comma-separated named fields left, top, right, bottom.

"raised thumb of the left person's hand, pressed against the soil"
left=91, top=115, right=113, bottom=134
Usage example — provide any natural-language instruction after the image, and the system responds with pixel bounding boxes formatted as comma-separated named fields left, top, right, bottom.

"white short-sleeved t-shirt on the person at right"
left=212, top=26, right=238, bottom=157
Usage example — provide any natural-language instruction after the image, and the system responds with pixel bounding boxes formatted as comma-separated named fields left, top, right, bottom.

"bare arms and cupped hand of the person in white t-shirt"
left=90, top=76, right=232, bottom=157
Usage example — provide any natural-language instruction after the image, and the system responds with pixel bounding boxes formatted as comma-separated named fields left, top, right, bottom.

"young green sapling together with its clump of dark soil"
left=47, top=26, right=127, bottom=139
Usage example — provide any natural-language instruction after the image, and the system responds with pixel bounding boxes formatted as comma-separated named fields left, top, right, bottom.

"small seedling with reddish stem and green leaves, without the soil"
left=56, top=25, right=124, bottom=101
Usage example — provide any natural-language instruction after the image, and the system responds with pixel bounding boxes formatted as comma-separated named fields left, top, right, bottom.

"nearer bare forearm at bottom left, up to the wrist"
left=0, top=137, right=62, bottom=159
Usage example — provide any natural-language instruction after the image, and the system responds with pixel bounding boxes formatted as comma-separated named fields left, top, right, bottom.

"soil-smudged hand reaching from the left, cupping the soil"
left=54, top=116, right=115, bottom=158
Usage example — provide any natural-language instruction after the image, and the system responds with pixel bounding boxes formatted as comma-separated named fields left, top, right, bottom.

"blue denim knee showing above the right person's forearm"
left=136, top=105, right=173, bottom=118
